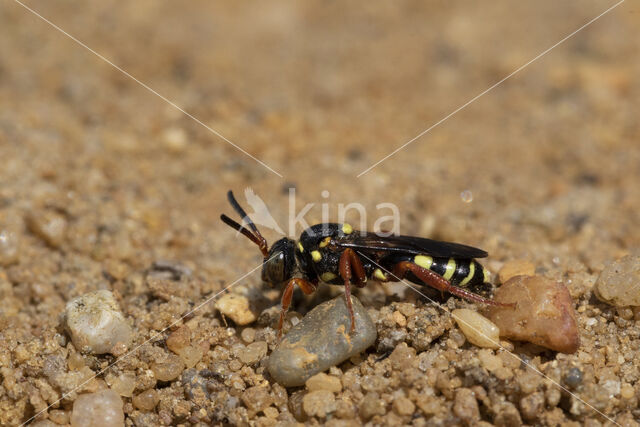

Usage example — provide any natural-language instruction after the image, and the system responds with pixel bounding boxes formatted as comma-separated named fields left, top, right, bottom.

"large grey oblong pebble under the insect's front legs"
left=267, top=296, right=377, bottom=387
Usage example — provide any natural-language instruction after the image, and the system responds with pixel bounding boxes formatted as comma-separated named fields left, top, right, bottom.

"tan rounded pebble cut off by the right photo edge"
left=594, top=253, right=640, bottom=307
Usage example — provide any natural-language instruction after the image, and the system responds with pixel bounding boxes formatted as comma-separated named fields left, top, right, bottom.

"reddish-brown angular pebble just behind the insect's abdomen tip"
left=487, top=276, right=580, bottom=353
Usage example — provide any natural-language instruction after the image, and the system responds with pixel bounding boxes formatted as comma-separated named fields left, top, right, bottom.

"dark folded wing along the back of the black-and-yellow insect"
left=335, top=234, right=488, bottom=258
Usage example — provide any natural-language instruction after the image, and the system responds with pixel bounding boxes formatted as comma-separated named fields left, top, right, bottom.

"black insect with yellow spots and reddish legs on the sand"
left=220, top=191, right=509, bottom=337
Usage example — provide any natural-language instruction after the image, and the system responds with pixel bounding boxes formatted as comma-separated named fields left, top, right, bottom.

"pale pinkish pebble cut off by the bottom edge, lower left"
left=71, top=390, right=124, bottom=427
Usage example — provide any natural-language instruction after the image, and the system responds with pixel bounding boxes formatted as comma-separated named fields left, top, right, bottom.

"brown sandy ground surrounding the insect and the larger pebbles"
left=0, top=0, right=640, bottom=426
